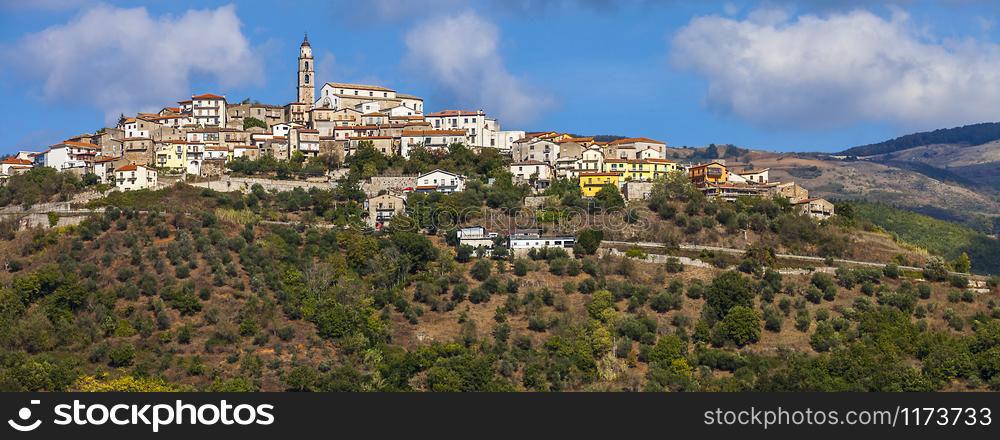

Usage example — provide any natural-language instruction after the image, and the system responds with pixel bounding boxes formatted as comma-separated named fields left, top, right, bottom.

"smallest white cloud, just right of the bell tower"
left=406, top=12, right=552, bottom=124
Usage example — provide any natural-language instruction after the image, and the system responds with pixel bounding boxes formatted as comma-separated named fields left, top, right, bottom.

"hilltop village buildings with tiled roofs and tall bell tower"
left=0, top=36, right=834, bottom=243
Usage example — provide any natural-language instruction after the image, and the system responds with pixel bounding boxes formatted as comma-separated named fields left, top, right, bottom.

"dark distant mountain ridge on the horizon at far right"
left=840, top=122, right=1000, bottom=156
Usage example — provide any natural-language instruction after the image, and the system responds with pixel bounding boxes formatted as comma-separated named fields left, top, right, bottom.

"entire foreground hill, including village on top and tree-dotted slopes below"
left=0, top=34, right=1000, bottom=392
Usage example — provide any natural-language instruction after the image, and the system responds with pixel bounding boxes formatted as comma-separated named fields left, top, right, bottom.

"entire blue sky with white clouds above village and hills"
left=0, top=0, right=1000, bottom=153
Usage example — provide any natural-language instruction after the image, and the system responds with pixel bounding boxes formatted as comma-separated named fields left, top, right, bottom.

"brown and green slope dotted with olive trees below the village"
left=0, top=157, right=1000, bottom=391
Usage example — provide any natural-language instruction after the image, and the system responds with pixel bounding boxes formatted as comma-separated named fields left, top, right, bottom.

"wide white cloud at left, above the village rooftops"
left=11, top=5, right=263, bottom=122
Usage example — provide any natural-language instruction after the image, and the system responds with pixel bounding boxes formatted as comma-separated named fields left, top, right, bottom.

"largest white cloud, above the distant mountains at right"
left=671, top=10, right=1000, bottom=128
